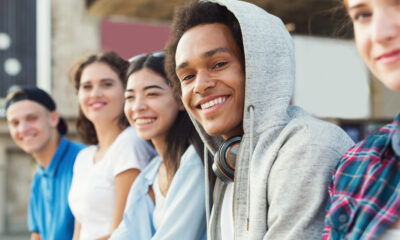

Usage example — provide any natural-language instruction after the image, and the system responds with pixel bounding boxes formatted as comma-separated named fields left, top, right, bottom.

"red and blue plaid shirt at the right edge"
left=322, top=114, right=400, bottom=240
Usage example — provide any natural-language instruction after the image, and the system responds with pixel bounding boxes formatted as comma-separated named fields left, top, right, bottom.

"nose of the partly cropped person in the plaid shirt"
left=371, top=10, right=400, bottom=43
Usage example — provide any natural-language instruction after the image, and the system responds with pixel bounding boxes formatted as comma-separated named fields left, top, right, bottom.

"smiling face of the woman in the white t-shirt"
left=78, top=62, right=124, bottom=125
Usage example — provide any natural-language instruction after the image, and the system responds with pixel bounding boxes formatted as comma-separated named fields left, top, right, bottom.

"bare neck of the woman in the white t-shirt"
left=94, top=123, right=123, bottom=151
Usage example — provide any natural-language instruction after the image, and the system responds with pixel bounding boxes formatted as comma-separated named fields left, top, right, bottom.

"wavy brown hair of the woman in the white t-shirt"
left=71, top=51, right=129, bottom=145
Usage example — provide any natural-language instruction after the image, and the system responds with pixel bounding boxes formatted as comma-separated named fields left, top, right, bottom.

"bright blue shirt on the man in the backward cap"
left=28, top=137, right=85, bottom=240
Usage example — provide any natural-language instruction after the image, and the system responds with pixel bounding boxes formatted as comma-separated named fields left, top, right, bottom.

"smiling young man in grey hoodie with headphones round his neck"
left=166, top=0, right=353, bottom=240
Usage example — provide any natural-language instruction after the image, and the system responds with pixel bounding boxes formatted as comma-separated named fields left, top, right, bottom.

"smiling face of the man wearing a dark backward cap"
left=6, top=100, right=59, bottom=154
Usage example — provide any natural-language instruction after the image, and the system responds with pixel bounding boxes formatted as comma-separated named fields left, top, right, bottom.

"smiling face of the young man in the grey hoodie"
left=175, top=23, right=245, bottom=139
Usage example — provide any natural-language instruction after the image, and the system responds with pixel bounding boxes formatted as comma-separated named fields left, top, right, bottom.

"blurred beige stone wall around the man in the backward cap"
left=0, top=0, right=100, bottom=237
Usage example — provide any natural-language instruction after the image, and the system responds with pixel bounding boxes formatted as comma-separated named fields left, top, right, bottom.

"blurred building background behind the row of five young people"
left=0, top=0, right=400, bottom=240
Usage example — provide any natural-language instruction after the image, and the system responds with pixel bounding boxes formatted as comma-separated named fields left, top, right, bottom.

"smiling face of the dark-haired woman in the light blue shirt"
left=125, top=68, right=183, bottom=143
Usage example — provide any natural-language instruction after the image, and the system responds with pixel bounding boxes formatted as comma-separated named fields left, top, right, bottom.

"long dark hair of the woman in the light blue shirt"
left=126, top=52, right=204, bottom=180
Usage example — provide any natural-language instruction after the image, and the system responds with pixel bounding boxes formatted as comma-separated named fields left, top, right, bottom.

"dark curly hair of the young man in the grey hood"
left=165, top=1, right=244, bottom=96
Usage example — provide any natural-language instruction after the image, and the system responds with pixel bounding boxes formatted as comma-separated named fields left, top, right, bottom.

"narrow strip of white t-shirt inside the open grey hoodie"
left=221, top=183, right=234, bottom=240
